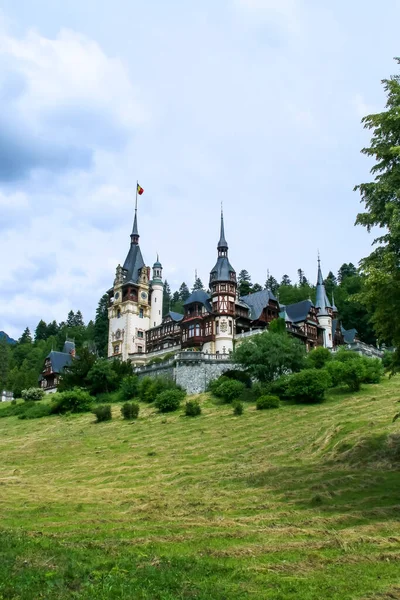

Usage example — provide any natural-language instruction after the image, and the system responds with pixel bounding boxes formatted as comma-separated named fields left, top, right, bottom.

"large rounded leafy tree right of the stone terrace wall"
left=234, top=331, right=306, bottom=382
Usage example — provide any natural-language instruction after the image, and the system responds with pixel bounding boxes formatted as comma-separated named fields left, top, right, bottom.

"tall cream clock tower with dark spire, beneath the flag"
left=108, top=206, right=150, bottom=361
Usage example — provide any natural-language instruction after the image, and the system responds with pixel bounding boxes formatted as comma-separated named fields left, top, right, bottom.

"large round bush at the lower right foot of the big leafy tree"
left=288, top=369, right=331, bottom=404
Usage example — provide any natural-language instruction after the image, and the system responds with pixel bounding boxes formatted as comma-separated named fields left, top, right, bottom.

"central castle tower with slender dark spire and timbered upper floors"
left=210, top=208, right=237, bottom=354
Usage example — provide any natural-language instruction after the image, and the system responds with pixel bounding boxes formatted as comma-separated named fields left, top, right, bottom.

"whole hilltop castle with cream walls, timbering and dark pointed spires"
left=108, top=208, right=357, bottom=365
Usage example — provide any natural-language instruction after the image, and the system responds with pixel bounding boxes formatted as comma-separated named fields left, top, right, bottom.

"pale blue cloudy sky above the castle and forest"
left=0, top=0, right=400, bottom=338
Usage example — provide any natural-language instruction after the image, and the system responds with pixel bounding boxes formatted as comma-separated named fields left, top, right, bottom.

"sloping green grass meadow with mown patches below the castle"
left=0, top=378, right=400, bottom=600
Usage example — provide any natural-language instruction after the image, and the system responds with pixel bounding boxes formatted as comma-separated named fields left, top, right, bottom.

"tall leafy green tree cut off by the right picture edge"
left=355, top=58, right=400, bottom=348
